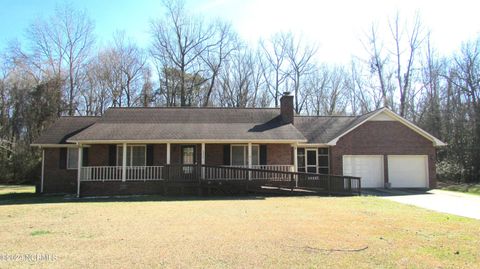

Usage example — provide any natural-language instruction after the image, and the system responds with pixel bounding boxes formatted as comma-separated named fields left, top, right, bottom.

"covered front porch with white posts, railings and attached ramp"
left=67, top=143, right=360, bottom=196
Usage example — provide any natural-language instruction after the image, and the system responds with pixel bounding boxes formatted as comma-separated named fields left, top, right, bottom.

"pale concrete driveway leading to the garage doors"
left=362, top=189, right=480, bottom=219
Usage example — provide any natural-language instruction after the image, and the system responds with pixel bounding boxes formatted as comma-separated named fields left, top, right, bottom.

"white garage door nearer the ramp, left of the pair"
left=343, top=155, right=384, bottom=188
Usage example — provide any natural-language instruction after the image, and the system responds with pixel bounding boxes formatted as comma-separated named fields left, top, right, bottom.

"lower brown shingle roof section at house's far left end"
left=32, top=117, right=99, bottom=145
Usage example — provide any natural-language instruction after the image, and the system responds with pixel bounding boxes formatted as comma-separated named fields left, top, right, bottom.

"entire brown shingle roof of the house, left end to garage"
left=34, top=107, right=386, bottom=144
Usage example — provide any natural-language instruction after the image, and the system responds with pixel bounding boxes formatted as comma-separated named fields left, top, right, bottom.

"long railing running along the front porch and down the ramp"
left=80, top=165, right=361, bottom=194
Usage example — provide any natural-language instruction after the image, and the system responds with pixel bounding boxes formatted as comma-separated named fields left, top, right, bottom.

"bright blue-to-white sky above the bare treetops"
left=0, top=0, right=480, bottom=63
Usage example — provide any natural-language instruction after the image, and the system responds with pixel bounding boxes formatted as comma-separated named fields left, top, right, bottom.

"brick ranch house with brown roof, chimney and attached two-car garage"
left=32, top=93, right=445, bottom=195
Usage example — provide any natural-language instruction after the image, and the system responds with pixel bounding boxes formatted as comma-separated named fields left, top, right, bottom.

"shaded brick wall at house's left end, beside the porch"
left=43, top=148, right=77, bottom=193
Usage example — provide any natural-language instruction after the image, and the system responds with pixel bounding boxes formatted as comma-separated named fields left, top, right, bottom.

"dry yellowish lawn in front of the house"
left=0, top=184, right=480, bottom=268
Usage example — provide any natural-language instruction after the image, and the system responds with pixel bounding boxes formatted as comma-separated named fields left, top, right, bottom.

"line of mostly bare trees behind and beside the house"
left=0, top=0, right=480, bottom=182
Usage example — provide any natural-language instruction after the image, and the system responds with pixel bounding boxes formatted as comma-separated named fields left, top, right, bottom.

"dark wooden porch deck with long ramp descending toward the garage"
left=80, top=165, right=361, bottom=196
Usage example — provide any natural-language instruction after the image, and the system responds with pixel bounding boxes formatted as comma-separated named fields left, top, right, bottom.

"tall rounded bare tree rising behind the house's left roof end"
left=27, top=5, right=94, bottom=115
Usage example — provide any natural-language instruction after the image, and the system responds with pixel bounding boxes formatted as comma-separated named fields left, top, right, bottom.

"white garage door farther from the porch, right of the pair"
left=388, top=155, right=428, bottom=188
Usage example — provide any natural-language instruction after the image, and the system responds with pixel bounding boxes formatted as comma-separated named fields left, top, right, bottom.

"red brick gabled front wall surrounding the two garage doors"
left=330, top=121, right=436, bottom=188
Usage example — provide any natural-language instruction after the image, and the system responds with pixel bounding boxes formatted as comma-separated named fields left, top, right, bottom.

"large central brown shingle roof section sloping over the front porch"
left=69, top=108, right=305, bottom=141
